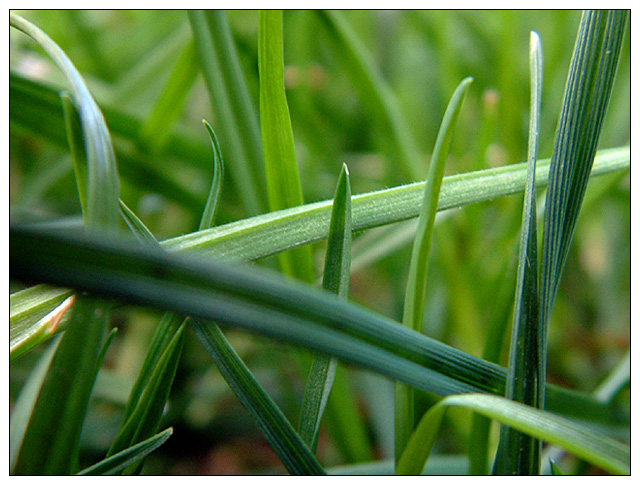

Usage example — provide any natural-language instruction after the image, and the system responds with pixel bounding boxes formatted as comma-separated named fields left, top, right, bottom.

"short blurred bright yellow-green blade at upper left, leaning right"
left=139, top=40, right=198, bottom=153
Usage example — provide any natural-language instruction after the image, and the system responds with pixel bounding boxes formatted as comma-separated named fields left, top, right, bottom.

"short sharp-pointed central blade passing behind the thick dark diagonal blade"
left=299, top=165, right=351, bottom=453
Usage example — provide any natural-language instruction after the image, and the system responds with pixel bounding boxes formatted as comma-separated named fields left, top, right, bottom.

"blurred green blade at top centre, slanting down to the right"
left=316, top=10, right=424, bottom=180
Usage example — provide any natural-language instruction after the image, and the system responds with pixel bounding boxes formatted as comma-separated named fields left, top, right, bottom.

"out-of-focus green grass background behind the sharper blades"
left=9, top=10, right=631, bottom=474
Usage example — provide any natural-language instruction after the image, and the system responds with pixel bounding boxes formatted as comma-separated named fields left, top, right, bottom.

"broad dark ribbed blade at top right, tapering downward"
left=539, top=10, right=628, bottom=408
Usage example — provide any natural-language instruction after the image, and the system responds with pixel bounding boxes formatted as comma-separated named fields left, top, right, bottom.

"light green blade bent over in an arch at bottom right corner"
left=397, top=394, right=631, bottom=475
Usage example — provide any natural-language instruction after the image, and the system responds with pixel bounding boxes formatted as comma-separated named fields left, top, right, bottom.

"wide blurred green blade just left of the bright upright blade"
left=189, top=10, right=267, bottom=215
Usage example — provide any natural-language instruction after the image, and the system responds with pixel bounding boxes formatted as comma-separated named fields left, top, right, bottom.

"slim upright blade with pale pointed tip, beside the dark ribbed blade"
left=494, top=32, right=544, bottom=475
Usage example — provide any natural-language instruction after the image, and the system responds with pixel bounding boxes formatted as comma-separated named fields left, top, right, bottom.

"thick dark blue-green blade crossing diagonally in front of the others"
left=9, top=227, right=627, bottom=428
